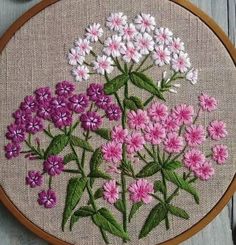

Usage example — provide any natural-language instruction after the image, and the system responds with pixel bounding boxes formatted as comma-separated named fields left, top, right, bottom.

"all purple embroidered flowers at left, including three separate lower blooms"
left=5, top=81, right=121, bottom=208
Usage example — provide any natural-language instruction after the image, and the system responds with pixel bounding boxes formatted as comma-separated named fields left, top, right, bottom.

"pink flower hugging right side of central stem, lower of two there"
left=126, top=132, right=145, bottom=154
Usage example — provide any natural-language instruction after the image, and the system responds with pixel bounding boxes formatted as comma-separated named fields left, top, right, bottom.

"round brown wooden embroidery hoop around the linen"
left=0, top=0, right=236, bottom=245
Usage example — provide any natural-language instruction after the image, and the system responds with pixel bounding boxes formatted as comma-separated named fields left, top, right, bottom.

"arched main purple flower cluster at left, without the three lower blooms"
left=5, top=81, right=121, bottom=159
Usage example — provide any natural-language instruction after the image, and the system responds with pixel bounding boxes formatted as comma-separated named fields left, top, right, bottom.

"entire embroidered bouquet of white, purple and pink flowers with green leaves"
left=5, top=13, right=229, bottom=243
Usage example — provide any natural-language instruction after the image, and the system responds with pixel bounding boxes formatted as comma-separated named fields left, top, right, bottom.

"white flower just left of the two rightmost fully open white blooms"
left=152, top=45, right=171, bottom=66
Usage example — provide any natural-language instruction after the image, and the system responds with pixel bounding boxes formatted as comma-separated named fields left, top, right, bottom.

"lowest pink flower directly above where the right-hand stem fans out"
left=164, top=133, right=183, bottom=153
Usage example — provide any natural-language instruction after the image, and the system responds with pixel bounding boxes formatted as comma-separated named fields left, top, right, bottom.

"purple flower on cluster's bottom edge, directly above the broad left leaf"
left=52, top=109, right=72, bottom=128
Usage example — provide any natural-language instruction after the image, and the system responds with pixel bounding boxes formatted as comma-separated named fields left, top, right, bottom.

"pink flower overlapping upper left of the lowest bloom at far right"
left=183, top=149, right=206, bottom=171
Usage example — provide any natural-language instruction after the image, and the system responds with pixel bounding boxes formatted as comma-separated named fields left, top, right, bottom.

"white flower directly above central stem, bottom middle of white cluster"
left=120, top=42, right=142, bottom=63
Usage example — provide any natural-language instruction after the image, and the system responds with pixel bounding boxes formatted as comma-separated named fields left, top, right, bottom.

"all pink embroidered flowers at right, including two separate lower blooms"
left=102, top=94, right=229, bottom=203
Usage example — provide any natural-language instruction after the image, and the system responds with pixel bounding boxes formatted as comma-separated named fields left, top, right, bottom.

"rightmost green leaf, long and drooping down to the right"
left=163, top=169, right=199, bottom=204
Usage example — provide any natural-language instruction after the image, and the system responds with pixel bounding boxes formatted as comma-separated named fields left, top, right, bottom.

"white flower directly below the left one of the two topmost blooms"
left=103, top=35, right=124, bottom=57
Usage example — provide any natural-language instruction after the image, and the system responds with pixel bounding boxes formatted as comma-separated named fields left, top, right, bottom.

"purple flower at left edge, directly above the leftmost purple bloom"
left=6, top=124, right=25, bottom=143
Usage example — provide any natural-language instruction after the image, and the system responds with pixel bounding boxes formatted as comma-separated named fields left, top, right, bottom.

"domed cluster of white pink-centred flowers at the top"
left=68, top=13, right=198, bottom=87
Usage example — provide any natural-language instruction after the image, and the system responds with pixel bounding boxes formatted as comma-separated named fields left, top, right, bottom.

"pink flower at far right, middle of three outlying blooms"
left=207, top=120, right=228, bottom=140
